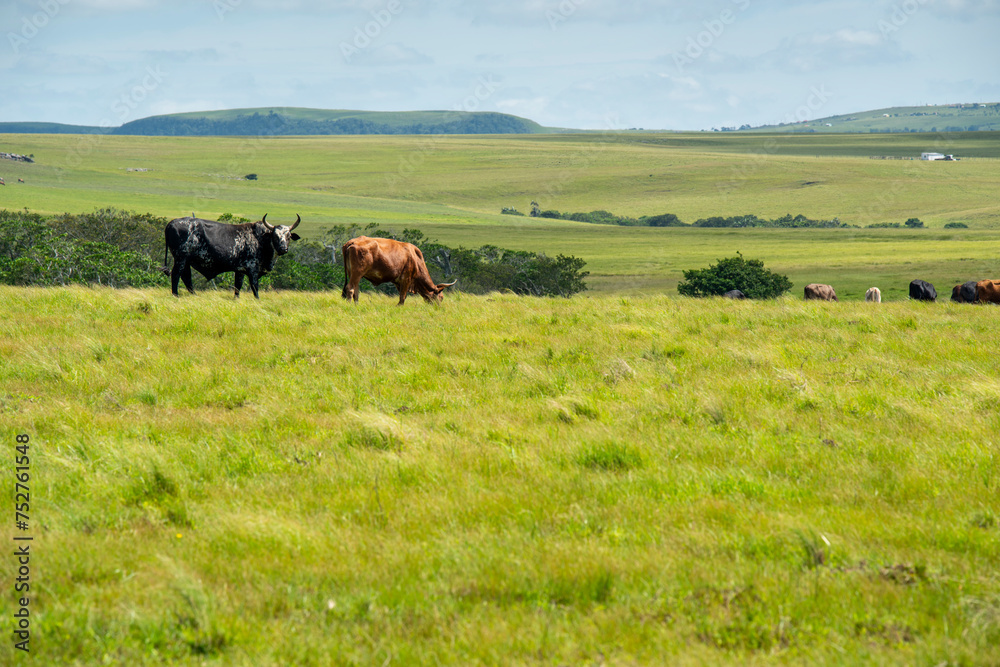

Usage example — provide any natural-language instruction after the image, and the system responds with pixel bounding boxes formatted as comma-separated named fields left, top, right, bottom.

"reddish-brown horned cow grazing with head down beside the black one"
left=341, top=236, right=455, bottom=306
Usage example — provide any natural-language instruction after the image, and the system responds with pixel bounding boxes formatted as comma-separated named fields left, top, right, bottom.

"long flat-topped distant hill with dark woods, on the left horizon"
left=0, top=107, right=549, bottom=137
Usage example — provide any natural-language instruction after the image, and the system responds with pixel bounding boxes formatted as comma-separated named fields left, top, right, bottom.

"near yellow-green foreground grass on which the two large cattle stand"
left=0, top=287, right=1000, bottom=665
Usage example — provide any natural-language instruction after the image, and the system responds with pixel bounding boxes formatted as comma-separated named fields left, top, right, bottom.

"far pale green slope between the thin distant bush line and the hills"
left=0, top=132, right=1000, bottom=229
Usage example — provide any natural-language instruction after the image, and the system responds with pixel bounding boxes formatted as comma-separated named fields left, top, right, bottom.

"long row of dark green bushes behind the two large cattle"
left=0, top=208, right=588, bottom=297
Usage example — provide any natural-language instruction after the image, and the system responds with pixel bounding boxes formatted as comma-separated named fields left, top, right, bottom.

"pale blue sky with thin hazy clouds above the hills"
left=0, top=0, right=1000, bottom=130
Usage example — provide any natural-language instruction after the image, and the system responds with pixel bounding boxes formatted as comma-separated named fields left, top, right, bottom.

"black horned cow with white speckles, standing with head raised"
left=163, top=214, right=302, bottom=299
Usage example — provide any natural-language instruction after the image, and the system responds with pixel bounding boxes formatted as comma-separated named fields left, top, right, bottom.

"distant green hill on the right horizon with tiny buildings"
left=748, top=103, right=1000, bottom=133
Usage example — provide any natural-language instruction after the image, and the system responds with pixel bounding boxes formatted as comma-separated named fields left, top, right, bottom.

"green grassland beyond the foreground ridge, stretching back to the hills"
left=0, top=132, right=1000, bottom=298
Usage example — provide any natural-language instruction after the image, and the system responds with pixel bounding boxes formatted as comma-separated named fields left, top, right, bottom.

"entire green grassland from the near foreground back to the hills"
left=0, top=133, right=1000, bottom=665
